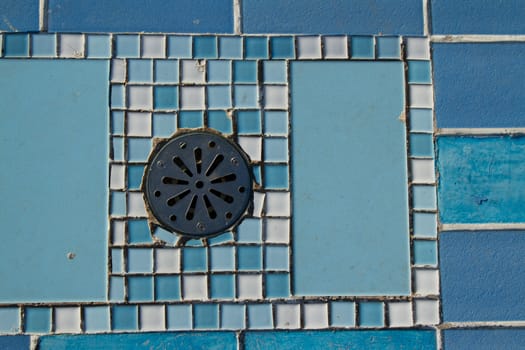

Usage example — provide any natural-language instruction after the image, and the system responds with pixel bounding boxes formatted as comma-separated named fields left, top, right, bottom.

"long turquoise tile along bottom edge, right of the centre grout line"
left=244, top=330, right=436, bottom=350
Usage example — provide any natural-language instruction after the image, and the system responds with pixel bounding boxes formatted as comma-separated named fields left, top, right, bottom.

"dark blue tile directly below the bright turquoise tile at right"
left=439, top=231, right=525, bottom=322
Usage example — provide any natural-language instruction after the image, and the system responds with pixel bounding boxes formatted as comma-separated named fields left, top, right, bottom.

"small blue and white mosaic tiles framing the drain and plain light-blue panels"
left=0, top=33, right=440, bottom=334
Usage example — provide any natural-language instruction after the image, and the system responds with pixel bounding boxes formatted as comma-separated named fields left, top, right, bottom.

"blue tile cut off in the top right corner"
left=431, top=0, right=525, bottom=34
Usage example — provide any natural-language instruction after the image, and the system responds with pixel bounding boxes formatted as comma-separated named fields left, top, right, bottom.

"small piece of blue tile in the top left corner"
left=0, top=0, right=38, bottom=32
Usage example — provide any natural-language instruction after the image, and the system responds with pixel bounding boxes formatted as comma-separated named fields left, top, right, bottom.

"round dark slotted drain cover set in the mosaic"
left=144, top=131, right=252, bottom=237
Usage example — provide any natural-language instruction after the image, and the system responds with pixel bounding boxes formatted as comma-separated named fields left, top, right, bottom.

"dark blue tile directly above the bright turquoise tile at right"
left=433, top=43, right=525, bottom=128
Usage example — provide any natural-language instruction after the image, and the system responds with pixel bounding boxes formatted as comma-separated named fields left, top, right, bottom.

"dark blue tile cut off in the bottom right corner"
left=443, top=328, right=525, bottom=350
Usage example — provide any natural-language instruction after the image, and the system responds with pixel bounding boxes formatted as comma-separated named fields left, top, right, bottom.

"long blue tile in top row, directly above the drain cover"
left=49, top=0, right=233, bottom=33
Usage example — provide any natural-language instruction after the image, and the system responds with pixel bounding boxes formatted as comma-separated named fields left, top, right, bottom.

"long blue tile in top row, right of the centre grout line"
left=242, top=0, right=423, bottom=35
